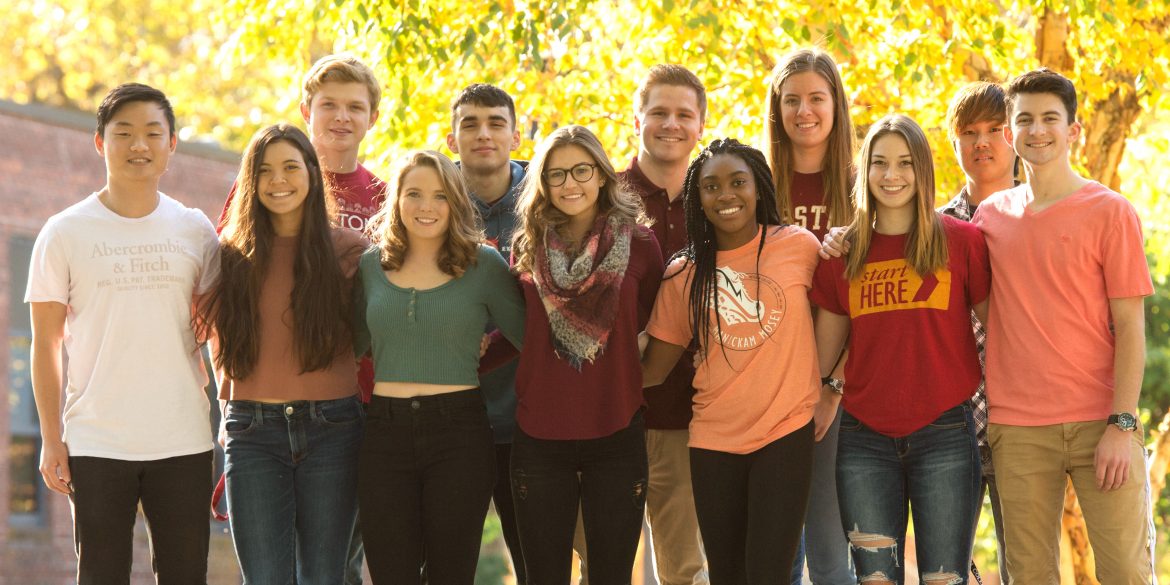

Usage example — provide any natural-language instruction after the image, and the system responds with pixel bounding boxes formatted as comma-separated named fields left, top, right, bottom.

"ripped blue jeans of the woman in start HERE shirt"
left=837, top=404, right=983, bottom=584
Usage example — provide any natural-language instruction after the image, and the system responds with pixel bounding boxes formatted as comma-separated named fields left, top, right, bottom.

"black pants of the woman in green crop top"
left=358, top=388, right=496, bottom=585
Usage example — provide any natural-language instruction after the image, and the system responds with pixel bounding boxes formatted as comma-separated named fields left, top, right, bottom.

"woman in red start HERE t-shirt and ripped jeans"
left=812, top=115, right=991, bottom=584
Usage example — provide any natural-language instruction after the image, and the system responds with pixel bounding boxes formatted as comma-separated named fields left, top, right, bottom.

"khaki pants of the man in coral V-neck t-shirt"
left=989, top=421, right=1154, bottom=585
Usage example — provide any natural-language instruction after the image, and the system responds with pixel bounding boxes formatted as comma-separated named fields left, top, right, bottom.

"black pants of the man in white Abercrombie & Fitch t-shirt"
left=69, top=450, right=212, bottom=585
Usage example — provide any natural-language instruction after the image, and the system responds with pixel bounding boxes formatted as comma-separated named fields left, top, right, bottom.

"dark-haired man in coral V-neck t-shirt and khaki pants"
left=972, top=69, right=1154, bottom=585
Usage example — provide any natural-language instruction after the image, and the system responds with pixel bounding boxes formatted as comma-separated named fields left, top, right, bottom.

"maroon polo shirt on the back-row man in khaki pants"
left=618, top=157, right=695, bottom=431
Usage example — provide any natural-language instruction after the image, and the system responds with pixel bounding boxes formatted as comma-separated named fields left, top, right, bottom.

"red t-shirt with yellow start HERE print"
left=812, top=216, right=991, bottom=436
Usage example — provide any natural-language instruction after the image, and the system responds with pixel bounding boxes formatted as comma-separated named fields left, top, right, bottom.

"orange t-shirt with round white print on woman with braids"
left=646, top=226, right=820, bottom=454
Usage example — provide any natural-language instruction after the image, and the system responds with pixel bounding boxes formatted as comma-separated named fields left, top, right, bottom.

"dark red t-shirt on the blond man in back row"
left=215, top=163, right=386, bottom=402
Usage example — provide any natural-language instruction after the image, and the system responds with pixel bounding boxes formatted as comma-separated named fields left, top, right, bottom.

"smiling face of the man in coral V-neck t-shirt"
left=1007, top=94, right=1081, bottom=167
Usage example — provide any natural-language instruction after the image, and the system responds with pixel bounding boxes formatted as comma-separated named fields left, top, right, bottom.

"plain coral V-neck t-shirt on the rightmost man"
left=971, top=183, right=1154, bottom=426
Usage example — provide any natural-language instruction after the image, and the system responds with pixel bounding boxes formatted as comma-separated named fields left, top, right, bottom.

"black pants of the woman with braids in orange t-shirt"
left=683, top=422, right=814, bottom=585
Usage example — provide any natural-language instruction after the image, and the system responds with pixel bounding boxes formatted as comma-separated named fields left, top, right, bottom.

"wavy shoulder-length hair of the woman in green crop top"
left=366, top=150, right=483, bottom=277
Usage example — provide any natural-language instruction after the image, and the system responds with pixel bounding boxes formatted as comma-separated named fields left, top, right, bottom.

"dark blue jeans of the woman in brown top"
left=223, top=397, right=363, bottom=585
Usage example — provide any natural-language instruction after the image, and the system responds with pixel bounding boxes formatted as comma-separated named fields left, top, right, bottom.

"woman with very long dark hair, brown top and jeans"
left=201, top=124, right=365, bottom=585
